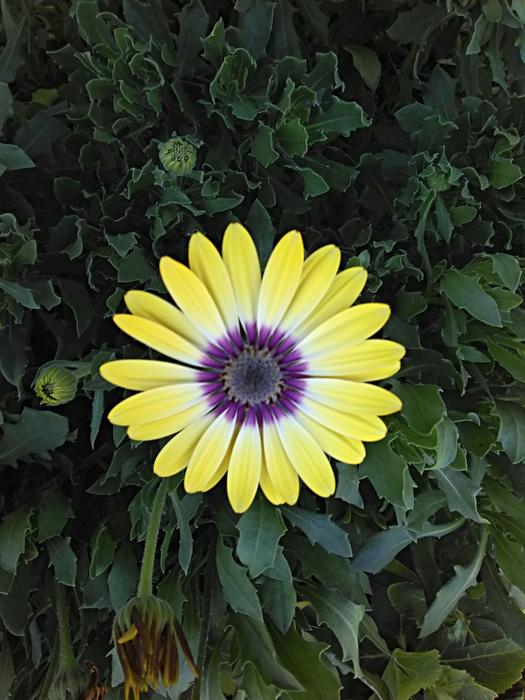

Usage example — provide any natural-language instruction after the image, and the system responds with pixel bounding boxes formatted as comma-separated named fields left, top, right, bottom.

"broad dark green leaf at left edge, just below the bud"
left=0, top=407, right=68, bottom=466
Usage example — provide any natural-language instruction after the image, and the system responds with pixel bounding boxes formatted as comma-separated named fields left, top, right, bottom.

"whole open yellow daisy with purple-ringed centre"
left=100, top=223, right=405, bottom=513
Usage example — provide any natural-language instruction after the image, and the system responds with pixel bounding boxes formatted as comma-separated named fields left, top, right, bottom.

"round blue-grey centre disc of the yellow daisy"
left=223, top=348, right=282, bottom=406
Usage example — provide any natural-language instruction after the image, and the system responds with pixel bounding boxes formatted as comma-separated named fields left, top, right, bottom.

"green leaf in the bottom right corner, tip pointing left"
left=444, top=639, right=525, bottom=700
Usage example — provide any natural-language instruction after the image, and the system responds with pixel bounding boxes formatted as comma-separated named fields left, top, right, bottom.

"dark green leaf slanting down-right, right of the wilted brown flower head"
left=231, top=614, right=303, bottom=691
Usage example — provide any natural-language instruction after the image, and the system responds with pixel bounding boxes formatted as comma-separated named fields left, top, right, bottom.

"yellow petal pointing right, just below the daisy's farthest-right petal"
left=306, top=377, right=401, bottom=416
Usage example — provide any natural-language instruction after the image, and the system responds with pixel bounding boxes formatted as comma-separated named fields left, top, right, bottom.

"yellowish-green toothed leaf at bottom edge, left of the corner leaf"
left=383, top=649, right=441, bottom=700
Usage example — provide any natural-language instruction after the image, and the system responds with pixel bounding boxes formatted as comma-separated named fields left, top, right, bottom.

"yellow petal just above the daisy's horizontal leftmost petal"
left=113, top=314, right=202, bottom=366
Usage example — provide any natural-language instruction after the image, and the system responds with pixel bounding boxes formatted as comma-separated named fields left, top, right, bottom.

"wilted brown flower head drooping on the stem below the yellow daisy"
left=113, top=596, right=197, bottom=700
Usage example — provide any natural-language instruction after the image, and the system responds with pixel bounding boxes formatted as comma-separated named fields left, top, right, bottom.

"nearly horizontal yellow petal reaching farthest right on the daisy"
left=308, top=338, right=405, bottom=381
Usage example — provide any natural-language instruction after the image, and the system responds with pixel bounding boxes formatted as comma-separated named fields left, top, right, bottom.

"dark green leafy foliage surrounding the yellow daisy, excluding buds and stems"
left=0, top=0, right=525, bottom=700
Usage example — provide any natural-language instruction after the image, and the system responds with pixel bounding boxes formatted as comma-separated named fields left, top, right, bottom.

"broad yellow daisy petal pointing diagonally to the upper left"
left=160, top=256, right=226, bottom=341
